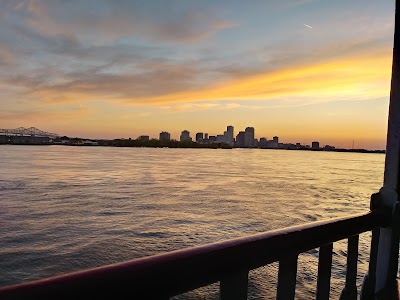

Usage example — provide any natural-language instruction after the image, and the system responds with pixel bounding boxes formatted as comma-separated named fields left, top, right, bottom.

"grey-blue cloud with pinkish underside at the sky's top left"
left=2, top=0, right=238, bottom=43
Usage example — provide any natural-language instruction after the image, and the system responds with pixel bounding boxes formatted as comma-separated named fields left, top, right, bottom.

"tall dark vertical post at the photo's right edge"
left=375, top=0, right=400, bottom=293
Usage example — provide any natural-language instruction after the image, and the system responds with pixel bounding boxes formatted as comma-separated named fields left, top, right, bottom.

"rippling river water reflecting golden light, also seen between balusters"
left=0, top=145, right=384, bottom=299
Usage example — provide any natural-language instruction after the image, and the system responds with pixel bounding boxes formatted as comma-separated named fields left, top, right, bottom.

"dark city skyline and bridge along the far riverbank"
left=0, top=125, right=368, bottom=153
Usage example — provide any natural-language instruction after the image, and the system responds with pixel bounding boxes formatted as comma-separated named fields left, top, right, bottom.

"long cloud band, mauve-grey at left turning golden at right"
left=6, top=40, right=391, bottom=106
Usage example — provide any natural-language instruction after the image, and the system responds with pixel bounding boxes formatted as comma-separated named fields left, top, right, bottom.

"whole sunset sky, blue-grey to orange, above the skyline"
left=0, top=0, right=394, bottom=149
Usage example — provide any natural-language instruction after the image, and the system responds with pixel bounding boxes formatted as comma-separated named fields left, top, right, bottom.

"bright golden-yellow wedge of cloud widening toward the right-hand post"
left=133, top=51, right=391, bottom=104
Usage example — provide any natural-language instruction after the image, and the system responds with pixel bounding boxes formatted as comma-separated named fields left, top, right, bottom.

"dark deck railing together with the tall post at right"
left=0, top=0, right=400, bottom=300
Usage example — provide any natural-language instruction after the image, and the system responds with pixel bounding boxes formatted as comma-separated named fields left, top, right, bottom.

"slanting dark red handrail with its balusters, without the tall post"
left=0, top=211, right=391, bottom=299
